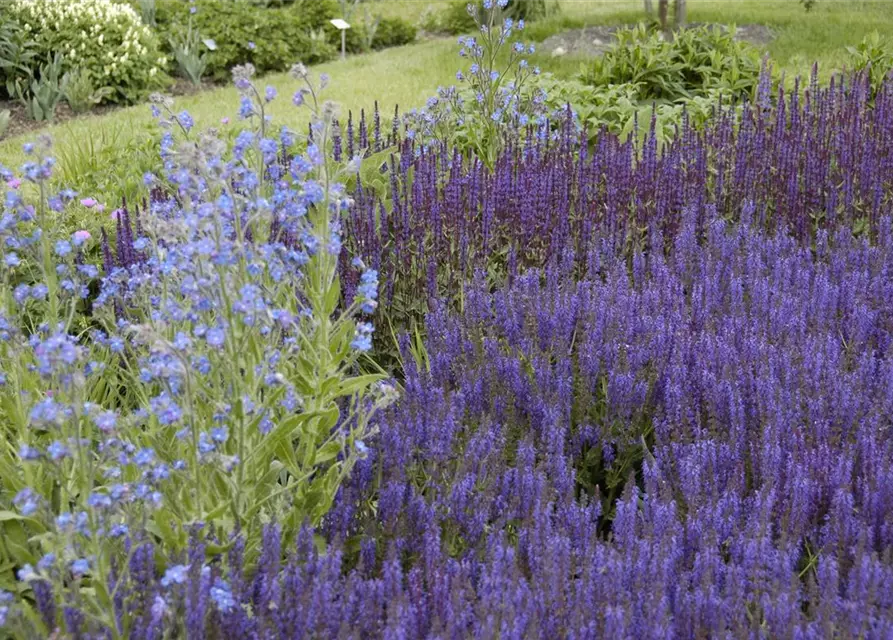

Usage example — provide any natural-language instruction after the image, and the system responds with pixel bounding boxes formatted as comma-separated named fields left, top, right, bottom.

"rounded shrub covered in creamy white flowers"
left=8, top=0, right=167, bottom=102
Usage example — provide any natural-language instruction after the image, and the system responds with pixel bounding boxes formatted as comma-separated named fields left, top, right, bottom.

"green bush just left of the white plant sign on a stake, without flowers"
left=186, top=0, right=335, bottom=80
